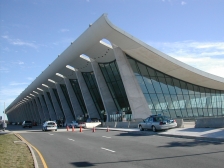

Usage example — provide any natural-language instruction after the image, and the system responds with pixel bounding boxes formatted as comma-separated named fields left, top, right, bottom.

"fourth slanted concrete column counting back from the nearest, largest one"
left=64, top=78, right=83, bottom=118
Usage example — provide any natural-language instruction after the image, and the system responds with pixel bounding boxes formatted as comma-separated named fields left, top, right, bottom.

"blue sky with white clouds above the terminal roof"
left=0, top=0, right=224, bottom=119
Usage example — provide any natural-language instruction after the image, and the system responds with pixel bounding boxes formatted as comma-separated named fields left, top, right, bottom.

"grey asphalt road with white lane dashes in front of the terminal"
left=7, top=128, right=224, bottom=168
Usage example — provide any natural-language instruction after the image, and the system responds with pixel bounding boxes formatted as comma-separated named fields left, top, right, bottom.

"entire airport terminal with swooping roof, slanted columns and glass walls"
left=6, top=14, right=224, bottom=123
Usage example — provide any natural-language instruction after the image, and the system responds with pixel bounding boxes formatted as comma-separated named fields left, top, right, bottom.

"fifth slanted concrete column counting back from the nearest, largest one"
left=55, top=83, right=74, bottom=123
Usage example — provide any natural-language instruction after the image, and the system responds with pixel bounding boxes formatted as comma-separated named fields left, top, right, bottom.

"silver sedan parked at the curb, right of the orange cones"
left=138, top=115, right=177, bottom=132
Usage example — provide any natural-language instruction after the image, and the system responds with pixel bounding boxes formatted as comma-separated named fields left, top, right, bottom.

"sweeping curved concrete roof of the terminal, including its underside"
left=6, top=14, right=224, bottom=112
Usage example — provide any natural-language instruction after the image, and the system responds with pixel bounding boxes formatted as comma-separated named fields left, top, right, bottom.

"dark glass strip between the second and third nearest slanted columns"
left=82, top=72, right=105, bottom=120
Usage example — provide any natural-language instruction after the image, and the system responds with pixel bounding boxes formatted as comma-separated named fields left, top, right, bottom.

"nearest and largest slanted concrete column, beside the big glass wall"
left=112, top=44, right=152, bottom=119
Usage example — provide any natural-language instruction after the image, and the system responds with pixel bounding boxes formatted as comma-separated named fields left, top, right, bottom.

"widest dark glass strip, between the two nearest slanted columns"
left=99, top=61, right=131, bottom=114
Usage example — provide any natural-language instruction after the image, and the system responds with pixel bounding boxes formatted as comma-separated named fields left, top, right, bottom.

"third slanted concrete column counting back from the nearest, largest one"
left=75, top=70, right=100, bottom=118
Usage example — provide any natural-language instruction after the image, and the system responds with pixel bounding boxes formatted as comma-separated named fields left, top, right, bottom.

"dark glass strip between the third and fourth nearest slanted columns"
left=70, top=79, right=87, bottom=116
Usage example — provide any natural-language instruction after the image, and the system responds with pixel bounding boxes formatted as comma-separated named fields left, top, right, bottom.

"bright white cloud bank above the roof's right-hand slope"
left=149, top=41, right=224, bottom=77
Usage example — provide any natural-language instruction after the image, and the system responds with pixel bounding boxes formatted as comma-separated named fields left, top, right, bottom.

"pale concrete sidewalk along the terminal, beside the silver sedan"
left=96, top=127, right=224, bottom=142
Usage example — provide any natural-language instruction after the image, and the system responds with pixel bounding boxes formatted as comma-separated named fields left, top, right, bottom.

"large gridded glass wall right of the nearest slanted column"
left=127, top=55, right=224, bottom=118
